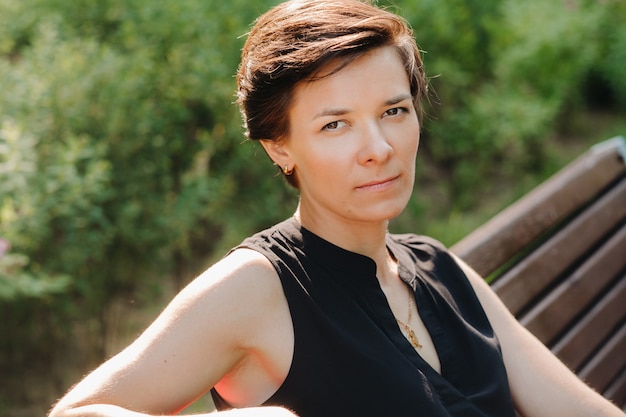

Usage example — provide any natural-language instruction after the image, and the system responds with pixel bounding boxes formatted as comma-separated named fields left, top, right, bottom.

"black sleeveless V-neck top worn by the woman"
left=212, top=218, right=515, bottom=417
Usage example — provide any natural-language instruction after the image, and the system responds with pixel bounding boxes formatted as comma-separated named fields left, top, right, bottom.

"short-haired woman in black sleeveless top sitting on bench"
left=51, top=0, right=621, bottom=417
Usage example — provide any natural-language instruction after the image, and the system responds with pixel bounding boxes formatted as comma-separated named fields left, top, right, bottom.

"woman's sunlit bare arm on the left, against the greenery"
left=50, top=250, right=293, bottom=417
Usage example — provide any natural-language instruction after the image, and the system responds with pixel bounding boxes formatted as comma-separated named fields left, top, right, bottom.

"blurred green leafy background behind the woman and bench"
left=0, top=0, right=626, bottom=416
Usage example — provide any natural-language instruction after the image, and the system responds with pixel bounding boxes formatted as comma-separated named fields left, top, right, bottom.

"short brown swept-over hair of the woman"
left=237, top=0, right=427, bottom=185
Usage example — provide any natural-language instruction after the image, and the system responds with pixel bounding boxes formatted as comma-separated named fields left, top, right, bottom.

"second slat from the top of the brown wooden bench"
left=492, top=180, right=626, bottom=314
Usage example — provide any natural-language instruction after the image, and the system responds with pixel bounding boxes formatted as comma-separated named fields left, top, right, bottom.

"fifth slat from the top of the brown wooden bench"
left=578, top=324, right=626, bottom=392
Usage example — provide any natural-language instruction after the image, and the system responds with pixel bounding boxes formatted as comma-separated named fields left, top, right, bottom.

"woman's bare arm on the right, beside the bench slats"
left=455, top=256, right=624, bottom=417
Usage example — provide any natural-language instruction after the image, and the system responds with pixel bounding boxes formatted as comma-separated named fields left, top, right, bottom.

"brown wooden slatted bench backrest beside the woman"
left=452, top=137, right=626, bottom=408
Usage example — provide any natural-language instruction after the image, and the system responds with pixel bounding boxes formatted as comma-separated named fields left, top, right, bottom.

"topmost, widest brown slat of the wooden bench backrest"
left=452, top=138, right=626, bottom=276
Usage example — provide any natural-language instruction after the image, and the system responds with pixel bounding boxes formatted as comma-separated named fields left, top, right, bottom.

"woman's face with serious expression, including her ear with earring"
left=264, top=47, right=420, bottom=229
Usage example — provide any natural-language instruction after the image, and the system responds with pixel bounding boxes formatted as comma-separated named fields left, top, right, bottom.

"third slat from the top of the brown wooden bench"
left=520, top=227, right=626, bottom=344
